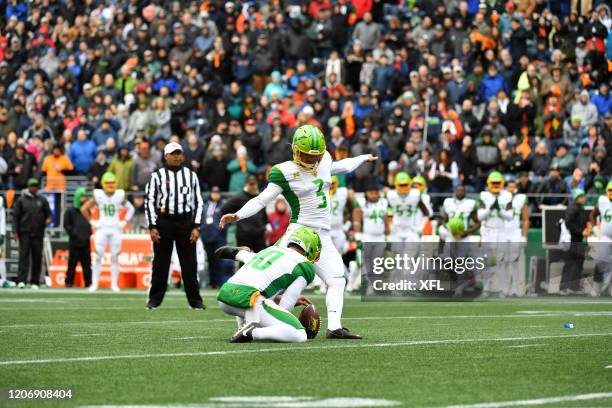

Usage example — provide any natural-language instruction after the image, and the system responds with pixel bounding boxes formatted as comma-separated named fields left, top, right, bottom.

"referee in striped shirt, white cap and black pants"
left=145, top=142, right=206, bottom=310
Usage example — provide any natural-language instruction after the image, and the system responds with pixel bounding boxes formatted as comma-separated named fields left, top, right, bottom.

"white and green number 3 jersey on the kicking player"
left=268, top=152, right=332, bottom=230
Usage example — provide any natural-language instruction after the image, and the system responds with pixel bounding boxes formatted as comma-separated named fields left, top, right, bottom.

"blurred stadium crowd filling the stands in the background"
left=0, top=0, right=612, bottom=217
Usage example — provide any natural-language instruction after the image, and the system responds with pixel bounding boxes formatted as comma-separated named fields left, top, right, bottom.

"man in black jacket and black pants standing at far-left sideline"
left=13, top=178, right=51, bottom=289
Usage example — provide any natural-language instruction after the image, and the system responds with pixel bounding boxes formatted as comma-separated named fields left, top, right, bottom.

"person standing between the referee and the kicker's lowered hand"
left=201, top=186, right=226, bottom=289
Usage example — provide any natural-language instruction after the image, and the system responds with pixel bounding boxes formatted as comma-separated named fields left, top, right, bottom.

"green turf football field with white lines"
left=0, top=290, right=612, bottom=408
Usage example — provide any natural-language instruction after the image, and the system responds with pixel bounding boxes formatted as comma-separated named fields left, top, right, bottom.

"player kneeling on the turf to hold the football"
left=216, top=227, right=321, bottom=343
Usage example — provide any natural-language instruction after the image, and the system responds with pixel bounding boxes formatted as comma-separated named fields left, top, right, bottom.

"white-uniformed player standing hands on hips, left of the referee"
left=81, top=172, right=134, bottom=292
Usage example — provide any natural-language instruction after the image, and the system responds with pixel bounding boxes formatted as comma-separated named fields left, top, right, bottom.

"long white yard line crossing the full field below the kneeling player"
left=0, top=333, right=612, bottom=366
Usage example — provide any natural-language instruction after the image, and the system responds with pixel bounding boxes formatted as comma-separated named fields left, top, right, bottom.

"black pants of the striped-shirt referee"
left=147, top=216, right=203, bottom=307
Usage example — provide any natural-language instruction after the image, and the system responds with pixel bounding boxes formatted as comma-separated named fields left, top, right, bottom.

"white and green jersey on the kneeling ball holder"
left=228, top=246, right=315, bottom=298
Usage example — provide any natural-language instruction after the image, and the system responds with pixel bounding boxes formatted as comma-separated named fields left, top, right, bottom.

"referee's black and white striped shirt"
left=145, top=167, right=204, bottom=228
